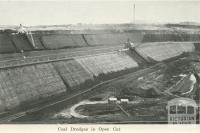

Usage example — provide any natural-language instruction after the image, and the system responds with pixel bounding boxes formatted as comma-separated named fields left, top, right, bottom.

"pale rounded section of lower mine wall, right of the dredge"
left=136, top=42, right=195, bottom=61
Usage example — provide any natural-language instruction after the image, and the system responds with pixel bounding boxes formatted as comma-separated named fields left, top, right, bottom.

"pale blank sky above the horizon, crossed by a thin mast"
left=0, top=0, right=200, bottom=26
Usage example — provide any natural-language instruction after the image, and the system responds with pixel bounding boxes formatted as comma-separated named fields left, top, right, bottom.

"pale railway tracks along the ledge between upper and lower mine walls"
left=0, top=46, right=122, bottom=69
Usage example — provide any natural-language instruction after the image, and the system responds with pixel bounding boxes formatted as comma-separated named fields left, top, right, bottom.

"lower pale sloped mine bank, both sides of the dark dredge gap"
left=0, top=42, right=198, bottom=117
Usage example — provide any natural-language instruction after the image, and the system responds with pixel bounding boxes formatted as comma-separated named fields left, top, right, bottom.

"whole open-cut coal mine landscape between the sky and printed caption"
left=0, top=24, right=200, bottom=124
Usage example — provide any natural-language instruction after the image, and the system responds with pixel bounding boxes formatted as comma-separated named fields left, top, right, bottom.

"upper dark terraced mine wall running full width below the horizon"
left=0, top=30, right=200, bottom=53
